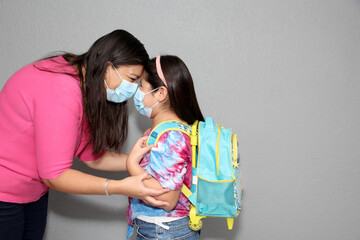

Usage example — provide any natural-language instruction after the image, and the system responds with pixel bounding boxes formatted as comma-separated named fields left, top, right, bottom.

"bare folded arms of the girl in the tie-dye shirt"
left=126, top=137, right=180, bottom=211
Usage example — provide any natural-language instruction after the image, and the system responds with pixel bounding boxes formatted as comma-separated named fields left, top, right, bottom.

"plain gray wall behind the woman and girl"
left=0, top=0, right=360, bottom=240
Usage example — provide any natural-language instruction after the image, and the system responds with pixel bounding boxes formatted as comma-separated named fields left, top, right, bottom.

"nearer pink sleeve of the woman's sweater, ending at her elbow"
left=33, top=74, right=82, bottom=179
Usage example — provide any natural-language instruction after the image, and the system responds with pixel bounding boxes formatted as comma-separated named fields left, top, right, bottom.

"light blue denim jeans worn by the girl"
left=134, top=217, right=200, bottom=240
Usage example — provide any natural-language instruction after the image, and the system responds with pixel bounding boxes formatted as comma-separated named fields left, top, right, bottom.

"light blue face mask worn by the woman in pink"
left=104, top=65, right=138, bottom=103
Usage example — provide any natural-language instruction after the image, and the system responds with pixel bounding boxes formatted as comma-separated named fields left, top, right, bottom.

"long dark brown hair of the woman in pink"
left=35, top=30, right=149, bottom=154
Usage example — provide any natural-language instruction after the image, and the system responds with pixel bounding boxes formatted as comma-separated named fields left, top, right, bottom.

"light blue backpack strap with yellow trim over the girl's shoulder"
left=146, top=121, right=190, bottom=146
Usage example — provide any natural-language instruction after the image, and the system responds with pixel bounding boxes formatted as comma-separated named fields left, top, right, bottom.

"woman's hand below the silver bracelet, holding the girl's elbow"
left=117, top=173, right=170, bottom=208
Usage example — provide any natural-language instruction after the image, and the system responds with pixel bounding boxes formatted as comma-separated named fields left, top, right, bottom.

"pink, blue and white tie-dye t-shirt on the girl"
left=127, top=123, right=191, bottom=232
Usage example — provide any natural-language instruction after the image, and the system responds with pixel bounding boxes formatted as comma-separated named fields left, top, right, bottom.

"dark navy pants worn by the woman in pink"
left=0, top=193, right=49, bottom=240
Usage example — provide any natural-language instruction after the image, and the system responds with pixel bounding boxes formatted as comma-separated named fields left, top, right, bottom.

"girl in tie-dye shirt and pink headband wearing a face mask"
left=127, top=56, right=204, bottom=239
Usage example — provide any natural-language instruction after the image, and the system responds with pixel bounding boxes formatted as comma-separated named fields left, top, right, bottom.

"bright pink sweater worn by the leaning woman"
left=0, top=57, right=104, bottom=203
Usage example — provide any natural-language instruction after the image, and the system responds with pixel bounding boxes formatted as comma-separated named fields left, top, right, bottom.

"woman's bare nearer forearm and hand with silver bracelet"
left=42, top=169, right=169, bottom=207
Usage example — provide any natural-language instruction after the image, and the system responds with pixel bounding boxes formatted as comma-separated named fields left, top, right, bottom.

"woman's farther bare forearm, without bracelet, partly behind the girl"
left=82, top=151, right=128, bottom=171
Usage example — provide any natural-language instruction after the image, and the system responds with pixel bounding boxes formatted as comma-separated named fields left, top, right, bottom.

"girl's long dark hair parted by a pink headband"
left=145, top=55, right=204, bottom=124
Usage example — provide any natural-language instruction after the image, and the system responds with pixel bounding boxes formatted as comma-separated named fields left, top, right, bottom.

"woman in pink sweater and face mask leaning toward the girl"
left=0, top=30, right=168, bottom=240
